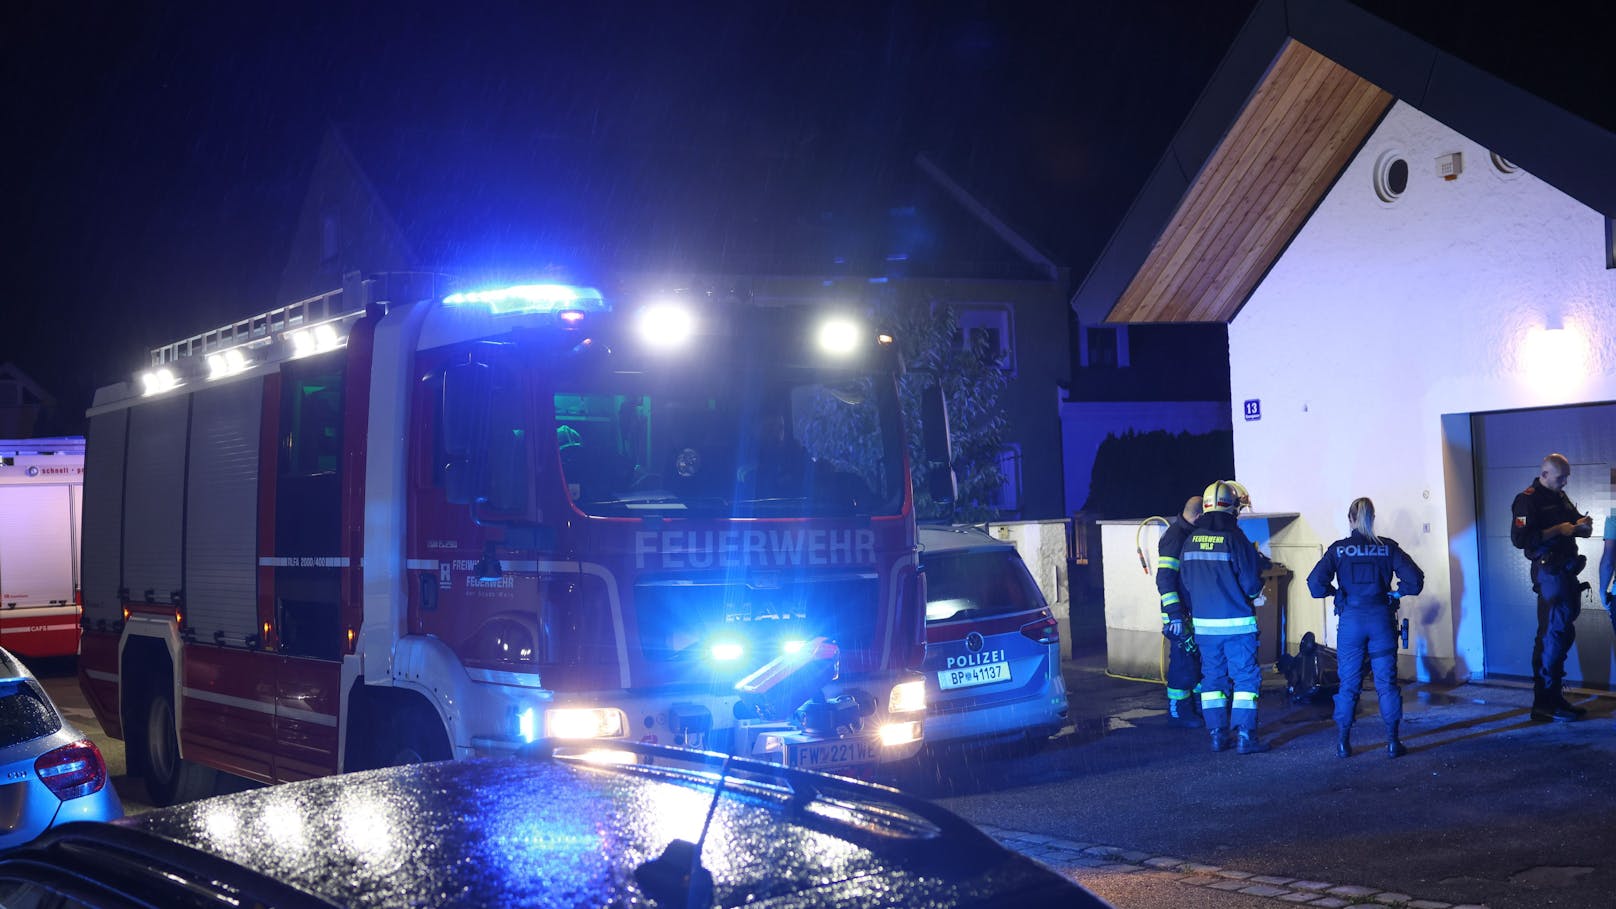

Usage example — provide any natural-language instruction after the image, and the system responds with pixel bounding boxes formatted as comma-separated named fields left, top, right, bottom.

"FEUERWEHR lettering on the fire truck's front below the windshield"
left=633, top=529, right=876, bottom=568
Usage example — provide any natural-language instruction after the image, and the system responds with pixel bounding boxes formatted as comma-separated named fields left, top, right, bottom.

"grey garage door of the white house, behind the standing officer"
left=1472, top=404, right=1616, bottom=689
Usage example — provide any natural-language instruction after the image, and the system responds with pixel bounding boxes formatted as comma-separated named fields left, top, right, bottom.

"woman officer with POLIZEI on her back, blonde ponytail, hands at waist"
left=1307, top=498, right=1425, bottom=757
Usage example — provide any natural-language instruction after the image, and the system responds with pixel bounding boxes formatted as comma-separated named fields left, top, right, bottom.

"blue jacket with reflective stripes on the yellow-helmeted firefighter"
left=1178, top=511, right=1262, bottom=636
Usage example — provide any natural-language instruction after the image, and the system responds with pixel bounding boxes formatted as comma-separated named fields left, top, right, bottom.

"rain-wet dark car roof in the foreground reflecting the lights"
left=120, top=759, right=1100, bottom=907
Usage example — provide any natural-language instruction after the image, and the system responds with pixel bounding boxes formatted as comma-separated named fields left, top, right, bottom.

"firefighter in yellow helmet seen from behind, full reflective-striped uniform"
left=1178, top=480, right=1269, bottom=754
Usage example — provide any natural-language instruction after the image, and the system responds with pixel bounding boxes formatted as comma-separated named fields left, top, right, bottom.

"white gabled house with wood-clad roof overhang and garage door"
left=1071, top=0, right=1616, bottom=686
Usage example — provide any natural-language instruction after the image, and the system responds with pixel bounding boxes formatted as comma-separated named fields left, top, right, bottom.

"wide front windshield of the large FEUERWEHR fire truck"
left=554, top=369, right=908, bottom=518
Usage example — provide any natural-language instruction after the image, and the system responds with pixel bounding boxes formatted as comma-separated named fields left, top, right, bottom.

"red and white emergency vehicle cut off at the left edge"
left=0, top=437, right=84, bottom=658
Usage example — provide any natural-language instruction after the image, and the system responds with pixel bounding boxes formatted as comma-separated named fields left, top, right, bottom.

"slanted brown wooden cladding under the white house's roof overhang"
left=1107, top=40, right=1393, bottom=322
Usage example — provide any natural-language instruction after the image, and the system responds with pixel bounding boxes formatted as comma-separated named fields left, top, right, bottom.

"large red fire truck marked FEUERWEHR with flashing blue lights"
left=79, top=278, right=953, bottom=804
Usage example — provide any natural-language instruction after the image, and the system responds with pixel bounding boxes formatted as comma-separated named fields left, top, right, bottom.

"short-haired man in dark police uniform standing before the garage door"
left=1509, top=453, right=1593, bottom=723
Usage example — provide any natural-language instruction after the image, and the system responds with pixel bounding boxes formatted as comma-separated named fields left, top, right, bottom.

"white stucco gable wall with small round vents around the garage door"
left=1230, top=102, right=1616, bottom=678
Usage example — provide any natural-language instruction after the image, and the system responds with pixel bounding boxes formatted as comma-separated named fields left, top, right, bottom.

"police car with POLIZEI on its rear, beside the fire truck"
left=920, top=527, right=1067, bottom=744
